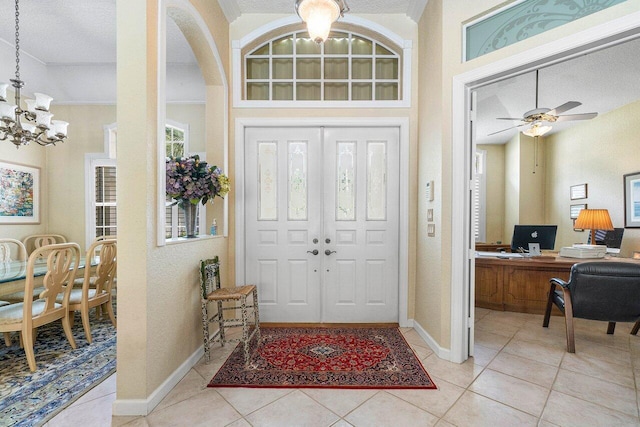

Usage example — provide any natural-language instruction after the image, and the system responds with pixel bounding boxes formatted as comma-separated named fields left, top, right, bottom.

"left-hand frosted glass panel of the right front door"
left=336, top=142, right=356, bottom=221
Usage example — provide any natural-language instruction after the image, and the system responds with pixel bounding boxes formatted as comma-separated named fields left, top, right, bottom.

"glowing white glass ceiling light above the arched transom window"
left=296, top=0, right=349, bottom=43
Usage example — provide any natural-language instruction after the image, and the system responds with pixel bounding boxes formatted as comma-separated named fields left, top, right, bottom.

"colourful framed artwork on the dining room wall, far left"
left=0, top=162, right=40, bottom=224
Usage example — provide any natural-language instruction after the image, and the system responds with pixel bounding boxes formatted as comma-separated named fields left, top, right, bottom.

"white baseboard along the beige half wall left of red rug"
left=112, top=346, right=204, bottom=416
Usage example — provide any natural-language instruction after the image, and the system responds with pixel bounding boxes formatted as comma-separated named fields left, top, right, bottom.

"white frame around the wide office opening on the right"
left=450, top=12, right=640, bottom=363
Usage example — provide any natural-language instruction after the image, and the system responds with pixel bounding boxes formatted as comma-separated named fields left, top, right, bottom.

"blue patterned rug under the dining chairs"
left=0, top=304, right=116, bottom=427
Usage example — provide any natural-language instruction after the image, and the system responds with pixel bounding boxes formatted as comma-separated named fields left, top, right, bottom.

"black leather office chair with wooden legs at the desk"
left=542, top=262, right=640, bottom=353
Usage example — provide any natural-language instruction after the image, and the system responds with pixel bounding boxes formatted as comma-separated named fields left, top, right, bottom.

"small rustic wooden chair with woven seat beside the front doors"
left=200, top=256, right=260, bottom=363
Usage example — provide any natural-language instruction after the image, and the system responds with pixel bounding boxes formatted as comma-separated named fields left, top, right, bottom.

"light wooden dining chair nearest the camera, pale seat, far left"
left=0, top=243, right=80, bottom=372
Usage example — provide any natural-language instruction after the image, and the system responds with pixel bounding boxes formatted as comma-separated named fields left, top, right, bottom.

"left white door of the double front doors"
left=245, top=128, right=322, bottom=322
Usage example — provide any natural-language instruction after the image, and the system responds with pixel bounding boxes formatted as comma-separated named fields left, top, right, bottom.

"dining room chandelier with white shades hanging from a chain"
left=0, top=0, right=69, bottom=148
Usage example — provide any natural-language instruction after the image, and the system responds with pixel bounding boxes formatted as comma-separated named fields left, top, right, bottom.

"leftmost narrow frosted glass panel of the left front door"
left=258, top=142, right=278, bottom=221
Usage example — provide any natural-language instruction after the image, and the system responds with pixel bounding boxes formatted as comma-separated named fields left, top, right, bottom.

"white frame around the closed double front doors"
left=233, top=117, right=412, bottom=327
